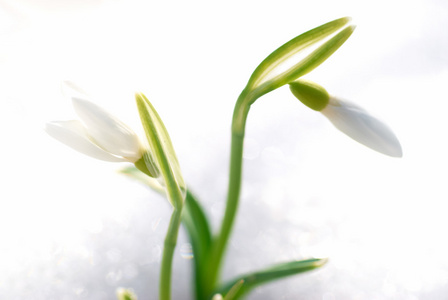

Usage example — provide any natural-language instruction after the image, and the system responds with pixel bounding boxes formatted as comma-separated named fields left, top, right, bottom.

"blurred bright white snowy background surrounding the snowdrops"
left=0, top=0, right=448, bottom=300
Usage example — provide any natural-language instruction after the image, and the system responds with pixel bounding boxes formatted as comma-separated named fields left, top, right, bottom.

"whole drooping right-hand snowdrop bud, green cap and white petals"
left=290, top=80, right=402, bottom=157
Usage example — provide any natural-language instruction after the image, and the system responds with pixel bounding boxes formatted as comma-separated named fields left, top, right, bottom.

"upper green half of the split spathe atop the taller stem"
left=247, top=17, right=350, bottom=90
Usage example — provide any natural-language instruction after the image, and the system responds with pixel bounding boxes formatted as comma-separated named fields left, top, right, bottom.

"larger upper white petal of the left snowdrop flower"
left=72, top=98, right=142, bottom=160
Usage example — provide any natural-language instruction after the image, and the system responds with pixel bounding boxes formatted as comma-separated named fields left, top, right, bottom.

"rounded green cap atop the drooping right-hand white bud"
left=289, top=79, right=330, bottom=111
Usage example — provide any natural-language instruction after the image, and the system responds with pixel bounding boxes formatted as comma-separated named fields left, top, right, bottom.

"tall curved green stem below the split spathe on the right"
left=206, top=90, right=253, bottom=294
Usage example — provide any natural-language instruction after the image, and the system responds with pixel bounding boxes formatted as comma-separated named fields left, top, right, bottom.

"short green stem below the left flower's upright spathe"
left=159, top=208, right=182, bottom=300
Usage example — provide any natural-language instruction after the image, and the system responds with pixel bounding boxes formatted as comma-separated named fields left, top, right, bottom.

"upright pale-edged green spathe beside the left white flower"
left=135, top=93, right=186, bottom=208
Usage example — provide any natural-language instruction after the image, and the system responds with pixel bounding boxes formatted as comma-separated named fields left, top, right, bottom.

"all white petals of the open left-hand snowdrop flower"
left=45, top=97, right=143, bottom=163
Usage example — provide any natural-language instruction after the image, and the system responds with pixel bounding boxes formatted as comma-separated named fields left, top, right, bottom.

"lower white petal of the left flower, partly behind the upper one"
left=45, top=121, right=126, bottom=162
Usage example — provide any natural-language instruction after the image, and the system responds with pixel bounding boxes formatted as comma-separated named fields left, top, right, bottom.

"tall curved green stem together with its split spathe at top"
left=207, top=18, right=354, bottom=291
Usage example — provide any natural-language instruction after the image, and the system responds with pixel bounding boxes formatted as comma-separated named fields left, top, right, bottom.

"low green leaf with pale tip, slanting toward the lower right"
left=217, top=258, right=327, bottom=300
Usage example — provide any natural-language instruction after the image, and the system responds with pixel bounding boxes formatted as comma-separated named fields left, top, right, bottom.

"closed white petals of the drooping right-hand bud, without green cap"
left=321, top=98, right=402, bottom=157
